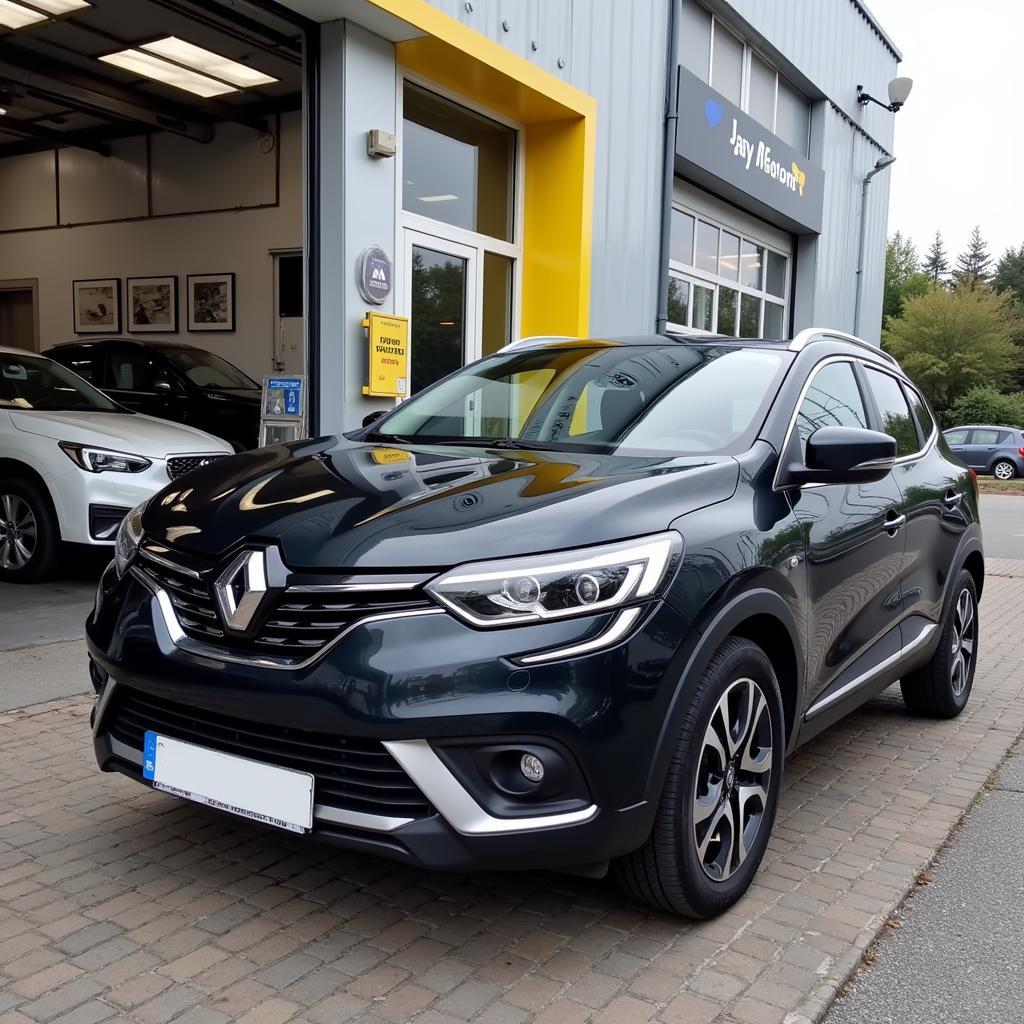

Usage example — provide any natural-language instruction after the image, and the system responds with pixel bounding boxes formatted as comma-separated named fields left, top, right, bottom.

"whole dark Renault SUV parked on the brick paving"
left=88, top=331, right=984, bottom=918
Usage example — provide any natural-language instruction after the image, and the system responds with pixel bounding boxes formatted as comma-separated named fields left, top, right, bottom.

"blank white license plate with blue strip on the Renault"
left=142, top=731, right=313, bottom=833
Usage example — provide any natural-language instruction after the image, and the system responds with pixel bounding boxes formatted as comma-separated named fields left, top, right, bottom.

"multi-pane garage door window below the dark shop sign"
left=669, top=208, right=790, bottom=338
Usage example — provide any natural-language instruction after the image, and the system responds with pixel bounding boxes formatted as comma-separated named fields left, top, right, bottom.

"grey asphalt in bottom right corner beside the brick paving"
left=825, top=744, right=1024, bottom=1024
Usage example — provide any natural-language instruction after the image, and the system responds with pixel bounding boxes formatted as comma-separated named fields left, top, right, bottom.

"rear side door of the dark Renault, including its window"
left=863, top=366, right=970, bottom=622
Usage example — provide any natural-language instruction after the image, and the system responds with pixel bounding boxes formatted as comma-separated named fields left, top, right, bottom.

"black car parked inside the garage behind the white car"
left=43, top=338, right=261, bottom=452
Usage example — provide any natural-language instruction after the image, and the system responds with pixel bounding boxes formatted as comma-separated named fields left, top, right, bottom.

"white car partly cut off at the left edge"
left=0, top=348, right=233, bottom=582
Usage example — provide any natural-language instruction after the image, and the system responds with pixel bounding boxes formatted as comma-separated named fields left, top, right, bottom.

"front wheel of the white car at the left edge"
left=0, top=478, right=60, bottom=583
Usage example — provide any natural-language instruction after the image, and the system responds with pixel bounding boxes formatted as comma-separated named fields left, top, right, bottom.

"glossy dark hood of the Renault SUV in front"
left=143, top=438, right=738, bottom=569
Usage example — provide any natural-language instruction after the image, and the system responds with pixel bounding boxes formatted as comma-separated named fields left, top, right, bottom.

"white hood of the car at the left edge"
left=8, top=409, right=231, bottom=459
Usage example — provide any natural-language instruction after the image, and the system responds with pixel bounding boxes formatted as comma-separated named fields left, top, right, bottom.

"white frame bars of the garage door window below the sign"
left=668, top=201, right=793, bottom=340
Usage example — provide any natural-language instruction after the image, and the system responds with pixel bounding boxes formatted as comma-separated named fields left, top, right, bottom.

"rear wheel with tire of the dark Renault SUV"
left=899, top=569, right=979, bottom=718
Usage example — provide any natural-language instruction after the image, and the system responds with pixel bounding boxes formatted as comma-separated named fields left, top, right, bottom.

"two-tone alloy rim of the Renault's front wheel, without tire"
left=692, top=679, right=773, bottom=882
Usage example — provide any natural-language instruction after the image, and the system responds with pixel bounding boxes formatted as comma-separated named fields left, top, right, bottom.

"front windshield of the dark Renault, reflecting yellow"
left=368, top=342, right=788, bottom=455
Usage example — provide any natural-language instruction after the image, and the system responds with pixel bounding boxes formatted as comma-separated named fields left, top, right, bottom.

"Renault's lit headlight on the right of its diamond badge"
left=426, top=531, right=683, bottom=626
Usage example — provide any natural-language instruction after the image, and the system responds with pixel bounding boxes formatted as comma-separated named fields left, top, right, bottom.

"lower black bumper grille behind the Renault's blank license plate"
left=103, top=686, right=434, bottom=818
